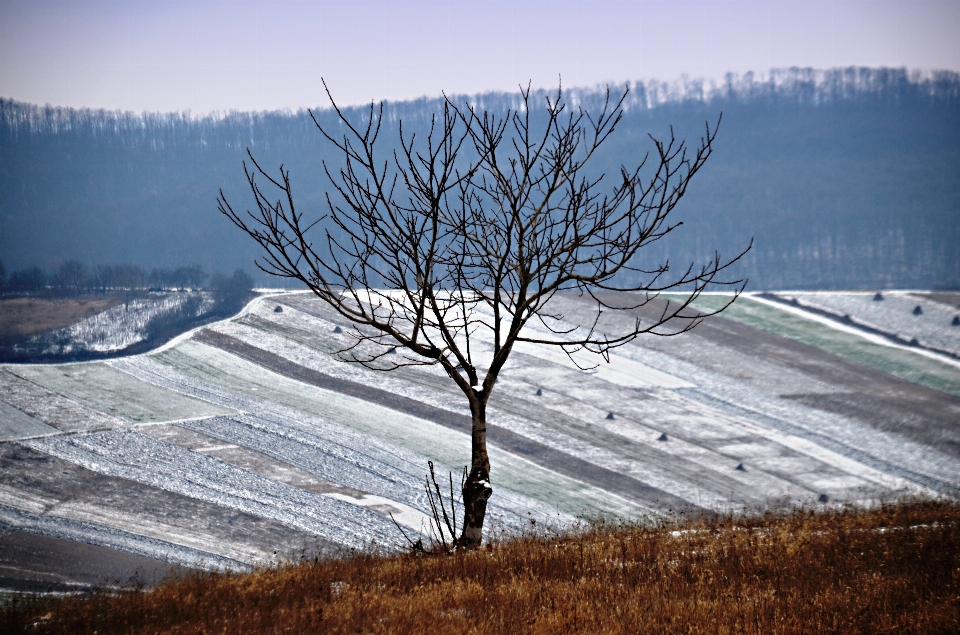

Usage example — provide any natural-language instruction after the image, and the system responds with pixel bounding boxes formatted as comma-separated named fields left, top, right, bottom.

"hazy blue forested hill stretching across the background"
left=0, top=68, right=960, bottom=289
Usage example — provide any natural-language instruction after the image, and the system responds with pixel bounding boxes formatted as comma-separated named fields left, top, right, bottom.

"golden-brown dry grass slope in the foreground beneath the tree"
left=0, top=502, right=960, bottom=635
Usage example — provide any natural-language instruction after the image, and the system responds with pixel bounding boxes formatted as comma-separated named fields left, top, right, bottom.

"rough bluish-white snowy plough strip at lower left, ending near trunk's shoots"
left=23, top=430, right=402, bottom=548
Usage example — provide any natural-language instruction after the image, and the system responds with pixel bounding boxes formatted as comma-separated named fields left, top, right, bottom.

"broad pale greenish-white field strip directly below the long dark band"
left=113, top=342, right=637, bottom=524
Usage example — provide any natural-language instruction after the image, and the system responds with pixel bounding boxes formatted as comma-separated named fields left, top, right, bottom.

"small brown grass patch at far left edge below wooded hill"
left=0, top=295, right=123, bottom=336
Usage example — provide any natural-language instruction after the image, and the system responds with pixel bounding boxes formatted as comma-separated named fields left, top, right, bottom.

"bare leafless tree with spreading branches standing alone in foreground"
left=218, top=87, right=749, bottom=549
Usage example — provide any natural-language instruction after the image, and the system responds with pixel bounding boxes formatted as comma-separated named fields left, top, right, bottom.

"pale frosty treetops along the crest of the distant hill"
left=0, top=67, right=960, bottom=137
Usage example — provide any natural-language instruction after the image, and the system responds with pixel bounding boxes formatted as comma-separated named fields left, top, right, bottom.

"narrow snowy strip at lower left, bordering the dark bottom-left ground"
left=0, top=503, right=251, bottom=571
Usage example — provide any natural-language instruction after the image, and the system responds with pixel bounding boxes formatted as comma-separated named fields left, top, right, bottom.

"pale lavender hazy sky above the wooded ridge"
left=0, top=0, right=960, bottom=114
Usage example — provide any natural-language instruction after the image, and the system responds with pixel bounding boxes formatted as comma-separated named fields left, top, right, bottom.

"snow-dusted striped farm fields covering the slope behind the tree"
left=0, top=294, right=960, bottom=588
